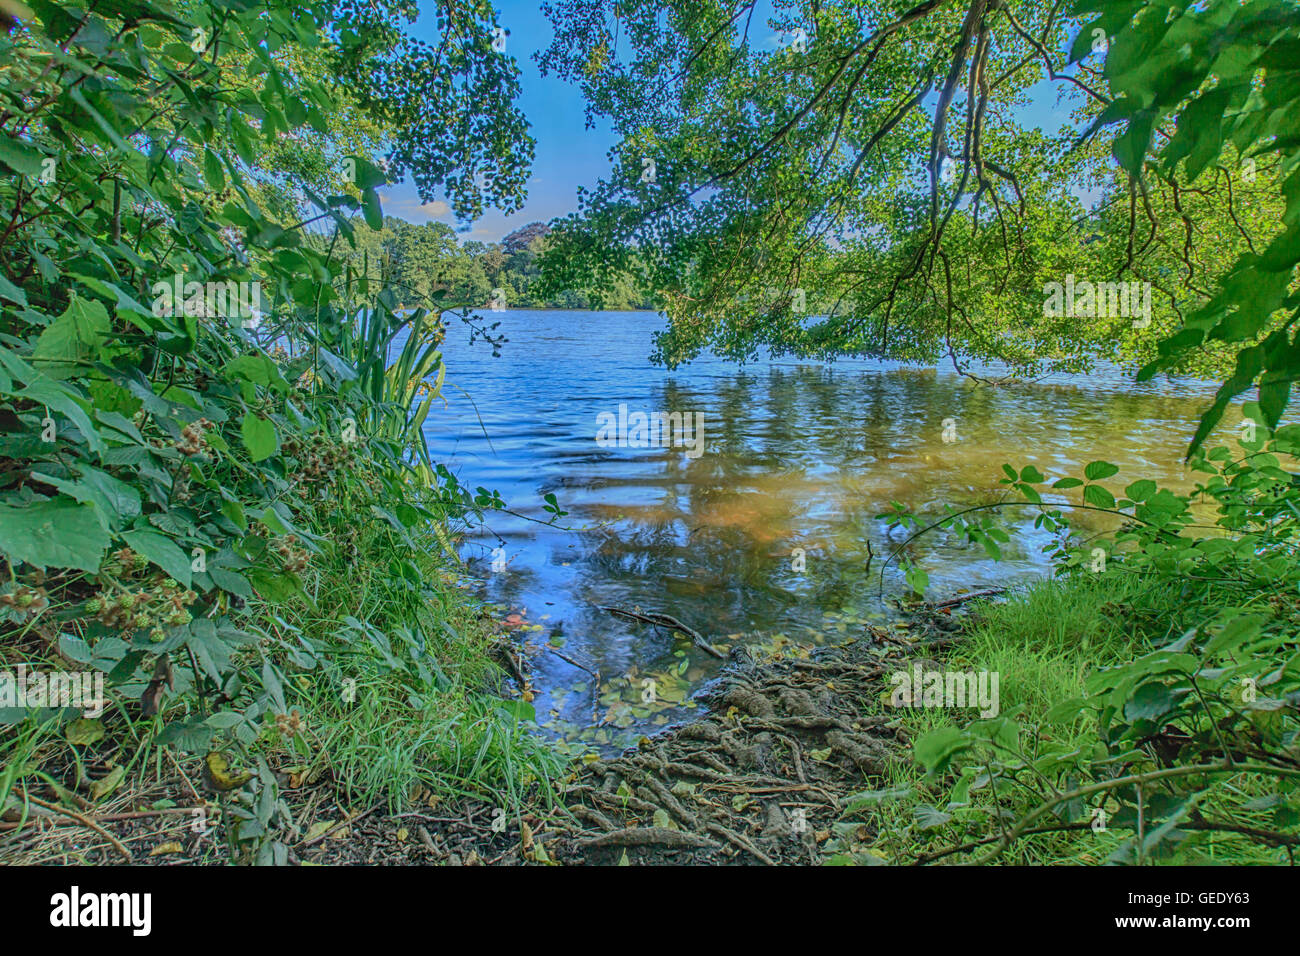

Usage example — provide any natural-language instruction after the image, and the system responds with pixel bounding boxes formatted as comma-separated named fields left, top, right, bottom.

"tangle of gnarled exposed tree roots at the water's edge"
left=553, top=621, right=941, bottom=865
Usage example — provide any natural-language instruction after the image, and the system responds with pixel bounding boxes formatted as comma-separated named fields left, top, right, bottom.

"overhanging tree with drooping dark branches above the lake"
left=540, top=0, right=1282, bottom=400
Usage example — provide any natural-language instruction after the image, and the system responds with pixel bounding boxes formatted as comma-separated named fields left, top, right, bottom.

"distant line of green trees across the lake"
left=335, top=216, right=655, bottom=310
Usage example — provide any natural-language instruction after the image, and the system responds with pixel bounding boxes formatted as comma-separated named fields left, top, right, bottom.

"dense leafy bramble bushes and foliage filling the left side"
left=0, top=0, right=543, bottom=861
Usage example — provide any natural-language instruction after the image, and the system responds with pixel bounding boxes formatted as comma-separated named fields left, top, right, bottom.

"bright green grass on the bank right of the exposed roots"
left=840, top=575, right=1287, bottom=865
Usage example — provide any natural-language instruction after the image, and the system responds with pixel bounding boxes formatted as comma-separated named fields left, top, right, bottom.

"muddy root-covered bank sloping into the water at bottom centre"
left=303, top=609, right=961, bottom=865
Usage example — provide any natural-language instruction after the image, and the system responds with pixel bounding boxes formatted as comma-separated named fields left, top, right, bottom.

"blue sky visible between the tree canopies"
left=384, top=0, right=1086, bottom=242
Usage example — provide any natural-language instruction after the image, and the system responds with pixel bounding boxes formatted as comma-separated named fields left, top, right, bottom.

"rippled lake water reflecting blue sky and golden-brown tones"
left=426, top=311, right=1237, bottom=744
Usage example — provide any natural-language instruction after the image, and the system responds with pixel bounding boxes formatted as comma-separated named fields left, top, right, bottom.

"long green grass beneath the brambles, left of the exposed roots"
left=282, top=520, right=563, bottom=809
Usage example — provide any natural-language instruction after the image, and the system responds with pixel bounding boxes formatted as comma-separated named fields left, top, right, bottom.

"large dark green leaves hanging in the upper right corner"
left=1074, top=0, right=1300, bottom=450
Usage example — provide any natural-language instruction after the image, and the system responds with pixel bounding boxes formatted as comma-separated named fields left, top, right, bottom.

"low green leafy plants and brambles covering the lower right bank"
left=868, top=421, right=1300, bottom=862
